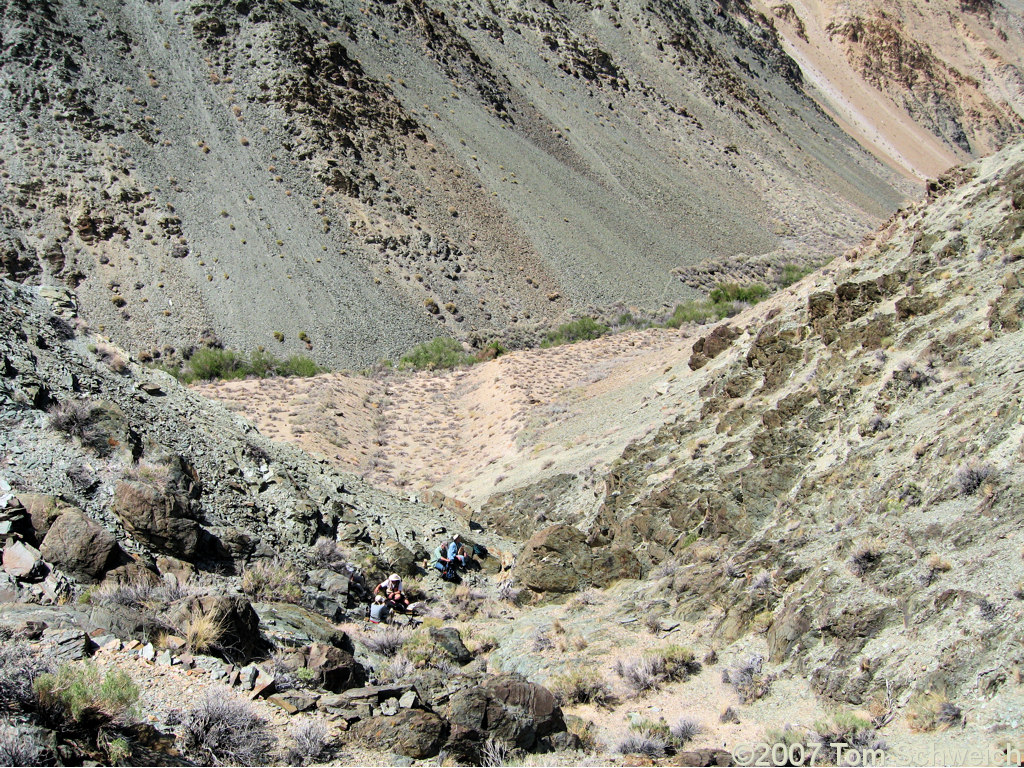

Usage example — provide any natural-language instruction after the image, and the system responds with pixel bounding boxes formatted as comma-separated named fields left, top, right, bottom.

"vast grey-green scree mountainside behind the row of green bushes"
left=0, top=0, right=921, bottom=367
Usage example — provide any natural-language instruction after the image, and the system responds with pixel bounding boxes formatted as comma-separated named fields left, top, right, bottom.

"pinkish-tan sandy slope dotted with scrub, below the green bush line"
left=198, top=330, right=696, bottom=506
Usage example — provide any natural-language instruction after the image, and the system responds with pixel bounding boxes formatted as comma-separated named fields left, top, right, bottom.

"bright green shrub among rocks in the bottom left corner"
left=33, top=662, right=138, bottom=723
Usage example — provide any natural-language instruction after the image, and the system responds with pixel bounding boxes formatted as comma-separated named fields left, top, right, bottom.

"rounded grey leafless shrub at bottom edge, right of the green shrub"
left=180, top=694, right=276, bottom=765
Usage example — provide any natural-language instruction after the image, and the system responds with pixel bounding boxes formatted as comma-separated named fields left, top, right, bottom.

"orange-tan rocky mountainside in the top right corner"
left=757, top=1, right=1024, bottom=178
